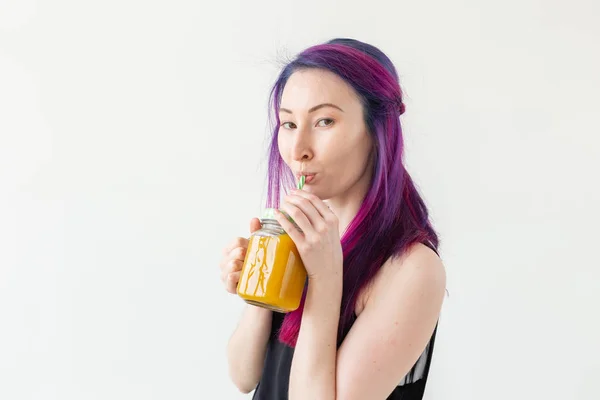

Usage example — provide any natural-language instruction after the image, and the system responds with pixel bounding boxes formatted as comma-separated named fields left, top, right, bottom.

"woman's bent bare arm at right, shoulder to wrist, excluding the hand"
left=289, top=245, right=446, bottom=400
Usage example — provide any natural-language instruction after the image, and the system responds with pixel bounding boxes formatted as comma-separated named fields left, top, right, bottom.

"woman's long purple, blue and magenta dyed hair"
left=267, top=38, right=438, bottom=347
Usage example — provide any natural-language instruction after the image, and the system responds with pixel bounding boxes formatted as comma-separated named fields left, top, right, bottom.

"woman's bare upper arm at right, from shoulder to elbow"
left=330, top=244, right=446, bottom=400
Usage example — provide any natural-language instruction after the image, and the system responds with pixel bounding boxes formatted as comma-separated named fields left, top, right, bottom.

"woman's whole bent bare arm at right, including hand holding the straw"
left=276, top=192, right=446, bottom=400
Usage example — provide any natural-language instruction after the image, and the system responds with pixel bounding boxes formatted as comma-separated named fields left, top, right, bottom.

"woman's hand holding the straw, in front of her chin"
left=276, top=190, right=344, bottom=281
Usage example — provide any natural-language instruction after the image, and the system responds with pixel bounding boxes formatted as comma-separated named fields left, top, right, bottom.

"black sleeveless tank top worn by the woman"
left=252, top=245, right=437, bottom=400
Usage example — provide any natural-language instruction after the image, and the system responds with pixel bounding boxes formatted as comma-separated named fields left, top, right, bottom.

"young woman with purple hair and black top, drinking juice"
left=221, top=39, right=446, bottom=400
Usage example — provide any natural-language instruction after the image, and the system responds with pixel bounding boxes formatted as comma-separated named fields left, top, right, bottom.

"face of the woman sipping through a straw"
left=278, top=69, right=373, bottom=200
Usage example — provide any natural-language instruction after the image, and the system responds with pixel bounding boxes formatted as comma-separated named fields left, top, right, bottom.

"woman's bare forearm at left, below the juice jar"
left=227, top=305, right=273, bottom=393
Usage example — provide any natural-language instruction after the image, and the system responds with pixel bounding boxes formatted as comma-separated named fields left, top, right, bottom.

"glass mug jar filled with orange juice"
left=237, top=208, right=306, bottom=313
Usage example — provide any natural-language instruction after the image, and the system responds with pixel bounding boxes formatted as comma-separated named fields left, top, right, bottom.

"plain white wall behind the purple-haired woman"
left=0, top=0, right=600, bottom=400
